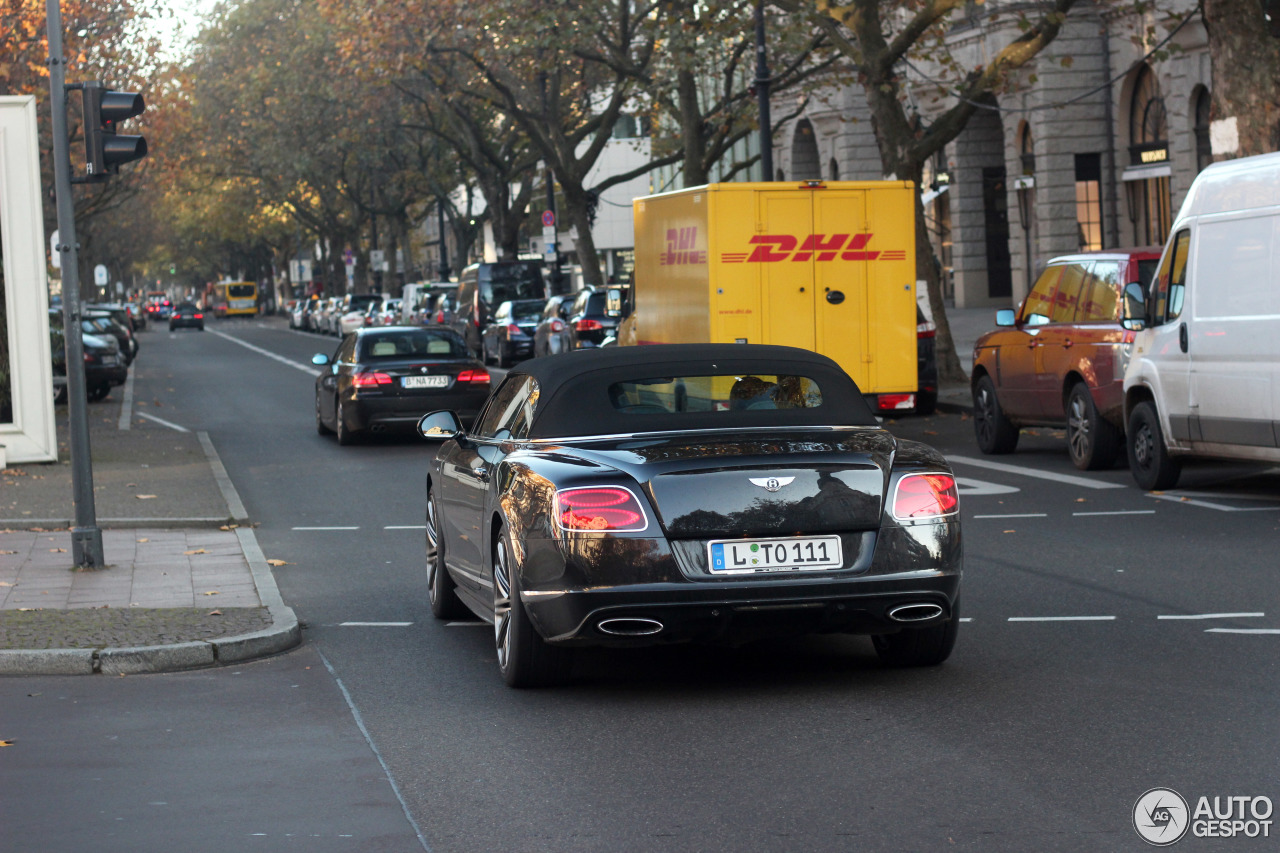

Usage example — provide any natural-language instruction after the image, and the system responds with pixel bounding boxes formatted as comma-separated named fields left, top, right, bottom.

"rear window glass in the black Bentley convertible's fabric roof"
left=609, top=374, right=822, bottom=415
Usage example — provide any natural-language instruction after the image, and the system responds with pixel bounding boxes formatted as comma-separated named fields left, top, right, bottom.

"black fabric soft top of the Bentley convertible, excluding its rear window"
left=509, top=343, right=877, bottom=438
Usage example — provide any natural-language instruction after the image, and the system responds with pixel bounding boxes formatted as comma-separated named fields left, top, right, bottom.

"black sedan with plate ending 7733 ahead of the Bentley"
left=311, top=325, right=489, bottom=444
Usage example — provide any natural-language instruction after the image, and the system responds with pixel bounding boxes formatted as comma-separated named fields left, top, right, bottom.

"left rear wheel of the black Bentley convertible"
left=493, top=525, right=573, bottom=688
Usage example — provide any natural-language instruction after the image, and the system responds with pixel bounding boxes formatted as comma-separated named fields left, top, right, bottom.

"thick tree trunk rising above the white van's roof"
left=1203, top=0, right=1280, bottom=156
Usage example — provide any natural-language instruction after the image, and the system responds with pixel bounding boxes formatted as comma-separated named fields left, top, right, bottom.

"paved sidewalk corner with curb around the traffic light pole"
left=0, top=371, right=301, bottom=675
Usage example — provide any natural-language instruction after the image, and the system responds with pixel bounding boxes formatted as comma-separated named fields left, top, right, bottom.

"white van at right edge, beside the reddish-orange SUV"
left=1124, top=154, right=1280, bottom=489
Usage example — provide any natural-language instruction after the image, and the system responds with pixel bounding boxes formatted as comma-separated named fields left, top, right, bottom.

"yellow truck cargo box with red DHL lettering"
left=618, top=181, right=916, bottom=412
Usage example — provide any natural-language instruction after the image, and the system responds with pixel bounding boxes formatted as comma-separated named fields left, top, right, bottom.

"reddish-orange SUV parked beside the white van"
left=970, top=246, right=1160, bottom=470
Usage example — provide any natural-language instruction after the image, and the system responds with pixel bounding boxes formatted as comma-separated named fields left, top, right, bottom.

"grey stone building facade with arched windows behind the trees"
left=774, top=3, right=1212, bottom=307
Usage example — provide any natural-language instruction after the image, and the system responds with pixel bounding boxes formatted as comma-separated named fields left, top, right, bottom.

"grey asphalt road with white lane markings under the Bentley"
left=10, top=321, right=1280, bottom=852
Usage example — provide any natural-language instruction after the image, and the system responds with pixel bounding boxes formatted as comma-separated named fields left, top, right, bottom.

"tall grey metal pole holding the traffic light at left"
left=45, top=0, right=106, bottom=569
